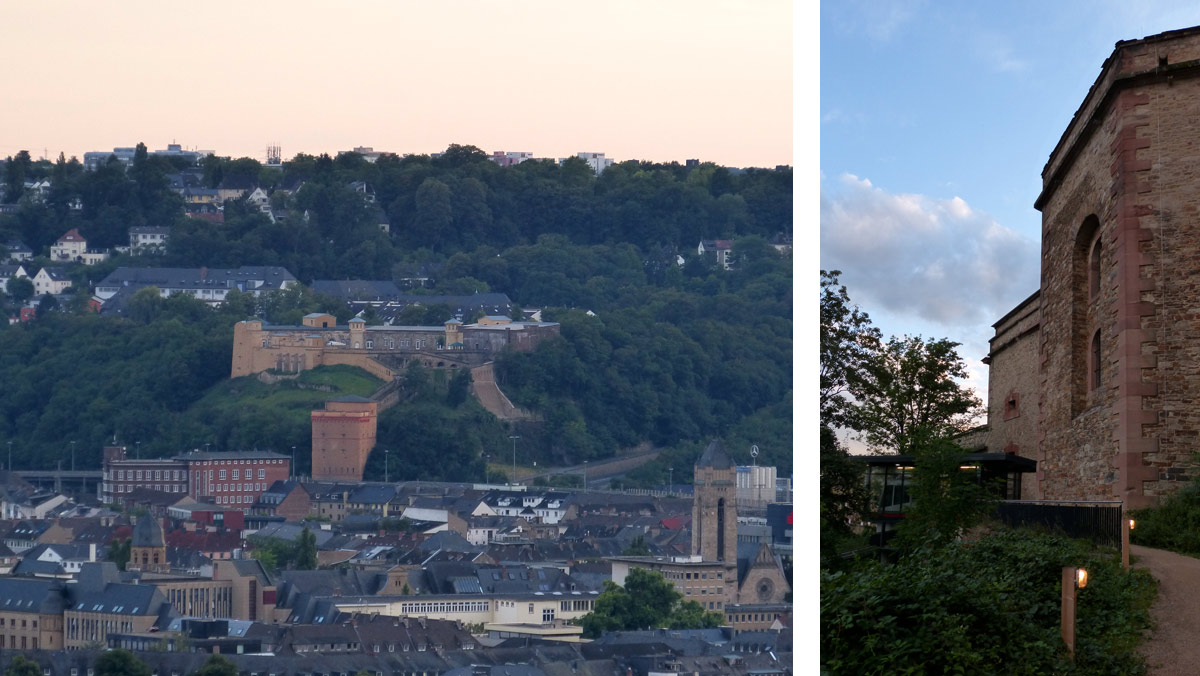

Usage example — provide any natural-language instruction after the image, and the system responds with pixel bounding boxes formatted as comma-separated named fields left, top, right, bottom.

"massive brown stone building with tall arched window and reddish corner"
left=989, top=26, right=1200, bottom=507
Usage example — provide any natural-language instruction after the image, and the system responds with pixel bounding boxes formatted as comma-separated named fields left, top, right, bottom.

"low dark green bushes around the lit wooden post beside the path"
left=821, top=530, right=1157, bottom=676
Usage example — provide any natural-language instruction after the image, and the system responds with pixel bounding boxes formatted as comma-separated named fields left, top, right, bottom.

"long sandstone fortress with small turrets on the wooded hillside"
left=230, top=313, right=558, bottom=381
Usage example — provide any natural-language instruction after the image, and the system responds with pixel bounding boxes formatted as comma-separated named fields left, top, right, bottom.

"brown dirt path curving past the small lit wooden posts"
left=1129, top=545, right=1200, bottom=676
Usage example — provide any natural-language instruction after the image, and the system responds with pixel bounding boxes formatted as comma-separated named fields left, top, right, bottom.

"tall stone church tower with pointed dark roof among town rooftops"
left=691, top=439, right=738, bottom=563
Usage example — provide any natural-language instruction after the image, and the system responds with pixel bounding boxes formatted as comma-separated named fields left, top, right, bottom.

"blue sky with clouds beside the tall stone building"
left=820, top=0, right=1200, bottom=422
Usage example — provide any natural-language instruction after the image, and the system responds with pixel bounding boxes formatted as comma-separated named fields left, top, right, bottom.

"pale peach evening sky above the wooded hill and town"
left=0, top=0, right=793, bottom=167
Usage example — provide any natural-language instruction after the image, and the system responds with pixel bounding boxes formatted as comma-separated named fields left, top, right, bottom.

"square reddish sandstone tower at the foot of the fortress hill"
left=312, top=396, right=379, bottom=481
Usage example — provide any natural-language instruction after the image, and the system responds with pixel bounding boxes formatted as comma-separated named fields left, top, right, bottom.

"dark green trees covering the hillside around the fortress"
left=0, top=144, right=792, bottom=477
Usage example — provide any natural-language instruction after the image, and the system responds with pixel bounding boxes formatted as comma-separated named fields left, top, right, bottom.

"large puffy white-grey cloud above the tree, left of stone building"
left=821, top=174, right=1039, bottom=340
